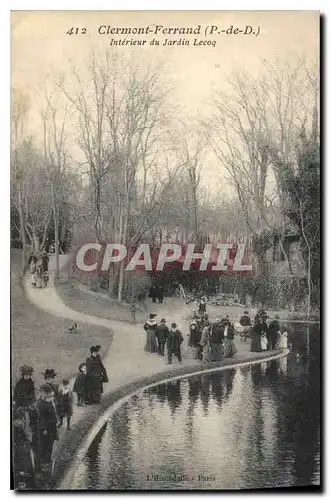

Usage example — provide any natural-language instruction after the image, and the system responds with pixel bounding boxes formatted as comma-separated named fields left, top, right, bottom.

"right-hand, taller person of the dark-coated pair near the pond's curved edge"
left=86, top=346, right=108, bottom=404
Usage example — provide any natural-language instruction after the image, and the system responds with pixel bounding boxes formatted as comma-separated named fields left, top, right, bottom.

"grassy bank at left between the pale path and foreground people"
left=11, top=250, right=112, bottom=385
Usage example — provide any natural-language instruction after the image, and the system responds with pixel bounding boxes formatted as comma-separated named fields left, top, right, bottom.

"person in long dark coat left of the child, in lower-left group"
left=37, top=384, right=58, bottom=469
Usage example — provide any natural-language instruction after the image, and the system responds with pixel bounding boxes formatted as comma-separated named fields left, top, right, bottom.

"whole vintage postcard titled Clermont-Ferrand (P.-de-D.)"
left=10, top=11, right=321, bottom=491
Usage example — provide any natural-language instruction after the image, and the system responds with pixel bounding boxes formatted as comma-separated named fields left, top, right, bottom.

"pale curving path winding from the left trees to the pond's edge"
left=24, top=267, right=286, bottom=488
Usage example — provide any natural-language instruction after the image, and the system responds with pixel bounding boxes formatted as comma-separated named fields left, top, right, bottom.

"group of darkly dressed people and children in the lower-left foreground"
left=13, top=345, right=108, bottom=489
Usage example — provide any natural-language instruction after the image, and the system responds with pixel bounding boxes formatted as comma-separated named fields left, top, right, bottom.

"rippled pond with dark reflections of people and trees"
left=73, top=325, right=320, bottom=490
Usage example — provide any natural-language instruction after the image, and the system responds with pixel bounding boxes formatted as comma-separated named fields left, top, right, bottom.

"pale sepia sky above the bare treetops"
left=11, top=11, right=319, bottom=191
